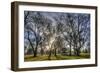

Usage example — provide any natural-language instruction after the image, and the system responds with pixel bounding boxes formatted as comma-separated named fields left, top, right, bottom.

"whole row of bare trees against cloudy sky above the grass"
left=24, top=11, right=90, bottom=59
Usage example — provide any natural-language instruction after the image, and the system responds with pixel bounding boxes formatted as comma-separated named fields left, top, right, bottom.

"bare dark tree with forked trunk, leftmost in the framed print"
left=24, top=12, right=41, bottom=57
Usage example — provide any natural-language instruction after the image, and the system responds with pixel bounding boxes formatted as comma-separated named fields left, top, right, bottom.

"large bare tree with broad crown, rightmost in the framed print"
left=64, top=13, right=90, bottom=56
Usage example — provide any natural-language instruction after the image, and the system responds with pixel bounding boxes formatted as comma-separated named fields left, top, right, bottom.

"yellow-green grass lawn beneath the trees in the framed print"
left=24, top=53, right=90, bottom=61
